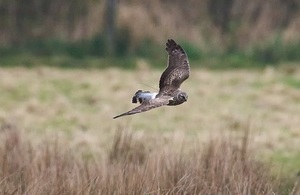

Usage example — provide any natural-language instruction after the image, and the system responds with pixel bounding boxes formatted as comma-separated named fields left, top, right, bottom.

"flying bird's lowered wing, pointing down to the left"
left=114, top=96, right=173, bottom=119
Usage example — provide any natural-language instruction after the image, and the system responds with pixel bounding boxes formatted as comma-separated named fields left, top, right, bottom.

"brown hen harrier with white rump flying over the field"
left=114, top=39, right=190, bottom=119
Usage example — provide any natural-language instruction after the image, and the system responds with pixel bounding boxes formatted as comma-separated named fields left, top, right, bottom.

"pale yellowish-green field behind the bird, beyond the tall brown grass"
left=0, top=68, right=300, bottom=175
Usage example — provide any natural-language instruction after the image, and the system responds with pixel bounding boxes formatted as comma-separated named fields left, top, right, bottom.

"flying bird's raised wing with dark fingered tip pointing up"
left=159, top=39, right=190, bottom=93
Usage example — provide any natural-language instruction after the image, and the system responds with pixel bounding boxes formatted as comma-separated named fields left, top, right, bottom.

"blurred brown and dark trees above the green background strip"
left=0, top=0, right=300, bottom=54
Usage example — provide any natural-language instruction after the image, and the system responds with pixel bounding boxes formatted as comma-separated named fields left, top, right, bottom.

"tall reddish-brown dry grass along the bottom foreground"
left=0, top=127, right=288, bottom=195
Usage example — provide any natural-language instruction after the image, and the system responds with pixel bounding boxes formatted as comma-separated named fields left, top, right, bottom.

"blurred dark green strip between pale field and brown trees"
left=0, top=37, right=300, bottom=69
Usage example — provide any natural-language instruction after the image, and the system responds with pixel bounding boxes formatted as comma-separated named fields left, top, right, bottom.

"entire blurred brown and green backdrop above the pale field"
left=0, top=0, right=300, bottom=68
